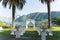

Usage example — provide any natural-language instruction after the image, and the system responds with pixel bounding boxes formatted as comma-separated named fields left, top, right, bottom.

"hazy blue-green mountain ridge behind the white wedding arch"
left=16, top=12, right=60, bottom=22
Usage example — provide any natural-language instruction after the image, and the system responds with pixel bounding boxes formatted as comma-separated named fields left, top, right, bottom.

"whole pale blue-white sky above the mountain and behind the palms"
left=0, top=0, right=60, bottom=18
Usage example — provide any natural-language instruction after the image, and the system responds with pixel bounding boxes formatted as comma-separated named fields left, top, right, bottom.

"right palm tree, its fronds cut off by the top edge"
left=41, top=0, right=54, bottom=28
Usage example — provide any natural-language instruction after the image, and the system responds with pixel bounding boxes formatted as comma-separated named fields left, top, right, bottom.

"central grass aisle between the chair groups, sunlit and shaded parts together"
left=23, top=28, right=39, bottom=38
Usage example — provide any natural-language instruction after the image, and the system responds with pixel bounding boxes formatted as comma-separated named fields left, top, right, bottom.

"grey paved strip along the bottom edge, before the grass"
left=0, top=35, right=40, bottom=40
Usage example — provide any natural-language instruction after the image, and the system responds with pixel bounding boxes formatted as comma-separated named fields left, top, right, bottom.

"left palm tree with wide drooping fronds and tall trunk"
left=2, top=0, right=26, bottom=34
